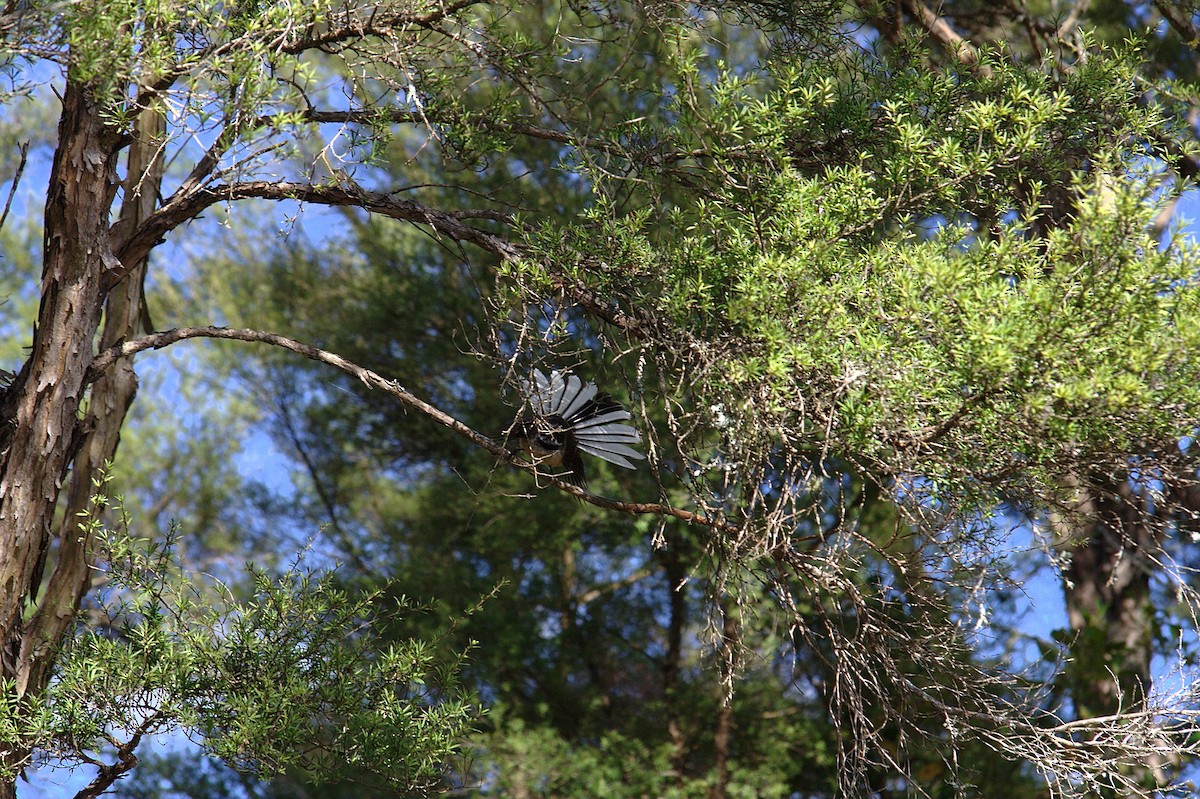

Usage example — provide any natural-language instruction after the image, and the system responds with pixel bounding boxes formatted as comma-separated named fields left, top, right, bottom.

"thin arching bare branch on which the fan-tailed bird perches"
left=88, top=326, right=737, bottom=531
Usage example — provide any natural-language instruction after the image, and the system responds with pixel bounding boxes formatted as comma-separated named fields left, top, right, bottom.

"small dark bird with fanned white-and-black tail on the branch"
left=506, top=370, right=646, bottom=488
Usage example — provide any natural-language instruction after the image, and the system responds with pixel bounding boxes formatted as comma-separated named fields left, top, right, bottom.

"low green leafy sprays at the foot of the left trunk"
left=0, top=489, right=475, bottom=791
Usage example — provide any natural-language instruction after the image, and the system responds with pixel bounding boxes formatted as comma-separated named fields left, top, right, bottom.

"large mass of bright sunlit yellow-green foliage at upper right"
left=526, top=38, right=1200, bottom=499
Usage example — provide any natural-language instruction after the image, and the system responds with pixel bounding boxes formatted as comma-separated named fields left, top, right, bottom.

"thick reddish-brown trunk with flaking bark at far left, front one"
left=0, top=74, right=120, bottom=798
